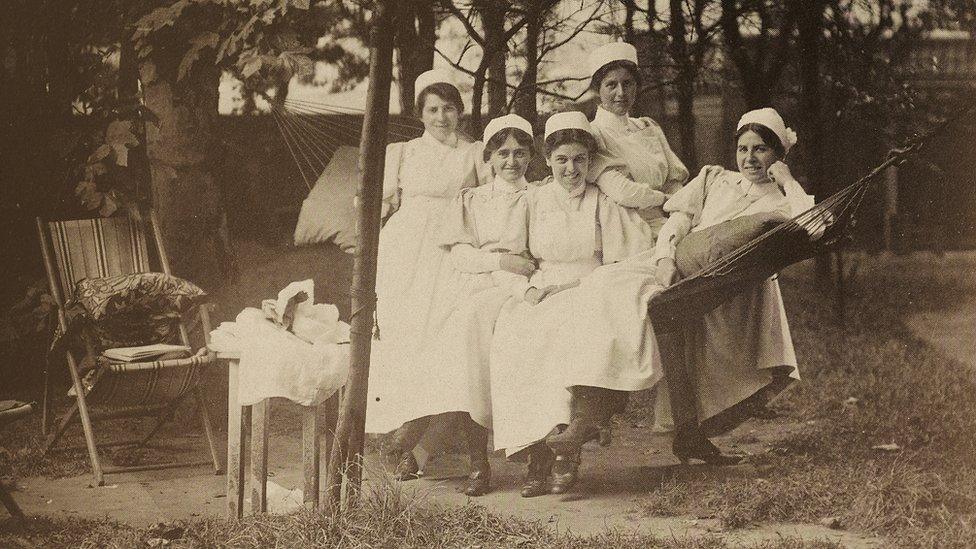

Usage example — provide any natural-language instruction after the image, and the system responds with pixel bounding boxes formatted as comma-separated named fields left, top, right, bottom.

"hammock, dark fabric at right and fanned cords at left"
left=271, top=99, right=960, bottom=334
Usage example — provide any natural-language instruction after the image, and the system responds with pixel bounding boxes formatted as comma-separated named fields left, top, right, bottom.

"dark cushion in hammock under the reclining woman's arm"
left=674, top=212, right=787, bottom=278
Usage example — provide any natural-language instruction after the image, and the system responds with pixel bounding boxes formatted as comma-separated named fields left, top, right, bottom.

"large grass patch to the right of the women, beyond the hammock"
left=643, top=254, right=976, bottom=547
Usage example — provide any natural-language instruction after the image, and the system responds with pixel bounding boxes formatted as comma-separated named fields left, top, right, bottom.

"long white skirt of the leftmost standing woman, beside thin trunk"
left=366, top=198, right=484, bottom=433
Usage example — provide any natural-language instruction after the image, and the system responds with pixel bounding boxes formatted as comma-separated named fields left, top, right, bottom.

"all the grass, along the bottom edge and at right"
left=0, top=249, right=976, bottom=549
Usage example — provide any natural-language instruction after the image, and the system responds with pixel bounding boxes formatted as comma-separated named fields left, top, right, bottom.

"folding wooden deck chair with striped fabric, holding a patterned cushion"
left=37, top=210, right=222, bottom=486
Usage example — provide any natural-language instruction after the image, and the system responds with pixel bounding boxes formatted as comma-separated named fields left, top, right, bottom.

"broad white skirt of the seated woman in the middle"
left=490, top=261, right=660, bottom=455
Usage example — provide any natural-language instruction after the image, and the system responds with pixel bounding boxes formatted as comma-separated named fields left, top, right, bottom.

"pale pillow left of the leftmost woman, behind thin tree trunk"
left=295, top=146, right=359, bottom=252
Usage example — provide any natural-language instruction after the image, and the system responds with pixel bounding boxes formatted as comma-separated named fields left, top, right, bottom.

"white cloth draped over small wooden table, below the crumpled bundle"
left=210, top=307, right=349, bottom=406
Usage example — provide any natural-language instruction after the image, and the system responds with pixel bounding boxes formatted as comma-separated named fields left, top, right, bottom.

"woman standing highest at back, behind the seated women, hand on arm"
left=589, top=42, right=688, bottom=233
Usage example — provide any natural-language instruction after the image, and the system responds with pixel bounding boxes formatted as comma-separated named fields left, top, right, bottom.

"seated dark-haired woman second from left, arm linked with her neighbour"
left=425, top=114, right=535, bottom=496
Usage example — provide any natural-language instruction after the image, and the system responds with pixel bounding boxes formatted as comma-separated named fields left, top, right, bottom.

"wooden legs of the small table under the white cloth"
left=217, top=352, right=341, bottom=519
